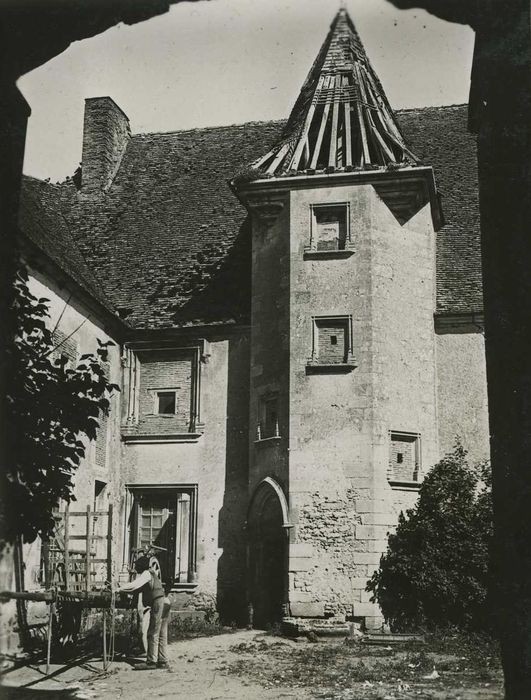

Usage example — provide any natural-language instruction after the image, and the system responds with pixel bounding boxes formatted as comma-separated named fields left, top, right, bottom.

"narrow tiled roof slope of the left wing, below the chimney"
left=19, top=177, right=121, bottom=315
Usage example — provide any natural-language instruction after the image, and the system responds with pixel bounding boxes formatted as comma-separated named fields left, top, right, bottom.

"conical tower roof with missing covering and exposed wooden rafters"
left=252, top=9, right=418, bottom=176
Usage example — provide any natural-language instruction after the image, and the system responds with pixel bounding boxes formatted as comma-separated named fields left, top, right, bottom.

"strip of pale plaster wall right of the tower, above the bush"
left=437, top=328, right=490, bottom=462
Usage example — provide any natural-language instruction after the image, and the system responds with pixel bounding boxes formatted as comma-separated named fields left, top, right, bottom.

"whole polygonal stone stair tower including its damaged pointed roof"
left=233, top=10, right=441, bottom=628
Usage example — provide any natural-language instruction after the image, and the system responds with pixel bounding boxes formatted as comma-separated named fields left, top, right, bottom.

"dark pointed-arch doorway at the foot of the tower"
left=247, top=477, right=289, bottom=629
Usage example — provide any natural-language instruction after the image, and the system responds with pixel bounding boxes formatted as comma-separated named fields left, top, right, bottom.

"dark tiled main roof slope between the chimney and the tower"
left=58, top=122, right=282, bottom=328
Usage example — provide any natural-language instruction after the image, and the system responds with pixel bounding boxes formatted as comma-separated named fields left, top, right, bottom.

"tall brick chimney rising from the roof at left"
left=81, top=97, right=131, bottom=194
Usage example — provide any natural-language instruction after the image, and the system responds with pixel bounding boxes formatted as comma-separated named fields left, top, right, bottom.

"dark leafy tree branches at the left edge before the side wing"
left=0, top=268, right=118, bottom=542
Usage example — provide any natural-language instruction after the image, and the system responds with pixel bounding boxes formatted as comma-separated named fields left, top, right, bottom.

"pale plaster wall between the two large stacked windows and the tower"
left=123, top=334, right=249, bottom=607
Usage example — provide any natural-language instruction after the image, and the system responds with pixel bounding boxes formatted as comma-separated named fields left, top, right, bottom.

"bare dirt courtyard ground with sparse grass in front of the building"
left=0, top=631, right=503, bottom=700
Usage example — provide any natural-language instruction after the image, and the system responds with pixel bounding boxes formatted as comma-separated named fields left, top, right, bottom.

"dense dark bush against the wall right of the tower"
left=367, top=444, right=492, bottom=631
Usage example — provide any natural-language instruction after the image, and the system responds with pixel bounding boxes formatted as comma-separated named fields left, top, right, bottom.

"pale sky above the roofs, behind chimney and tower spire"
left=18, top=0, right=474, bottom=182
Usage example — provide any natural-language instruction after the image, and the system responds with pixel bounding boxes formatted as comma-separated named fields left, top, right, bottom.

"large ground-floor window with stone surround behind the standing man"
left=127, top=485, right=197, bottom=585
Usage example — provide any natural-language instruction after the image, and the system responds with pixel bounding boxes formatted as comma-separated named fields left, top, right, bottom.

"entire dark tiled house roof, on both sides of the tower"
left=21, top=105, right=482, bottom=329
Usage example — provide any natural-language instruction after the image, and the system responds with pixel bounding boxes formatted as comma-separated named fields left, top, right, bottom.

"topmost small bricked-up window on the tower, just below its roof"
left=305, top=202, right=352, bottom=257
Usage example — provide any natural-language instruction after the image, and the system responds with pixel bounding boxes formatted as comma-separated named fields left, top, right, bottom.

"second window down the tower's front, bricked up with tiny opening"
left=307, top=316, right=354, bottom=371
